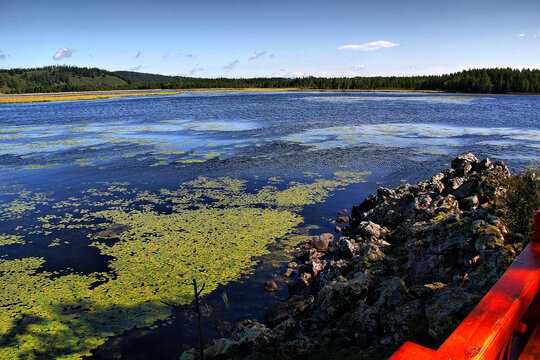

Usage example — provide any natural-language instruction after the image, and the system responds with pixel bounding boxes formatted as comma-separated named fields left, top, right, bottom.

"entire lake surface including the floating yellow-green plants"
left=0, top=92, right=540, bottom=359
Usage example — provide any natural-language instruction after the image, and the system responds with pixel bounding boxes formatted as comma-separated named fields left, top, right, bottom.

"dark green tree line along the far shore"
left=0, top=66, right=540, bottom=94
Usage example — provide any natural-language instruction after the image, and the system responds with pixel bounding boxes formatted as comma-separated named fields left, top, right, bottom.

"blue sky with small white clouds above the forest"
left=0, top=0, right=540, bottom=77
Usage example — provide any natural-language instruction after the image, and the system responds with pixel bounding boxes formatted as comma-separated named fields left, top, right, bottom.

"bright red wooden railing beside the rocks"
left=389, top=210, right=540, bottom=360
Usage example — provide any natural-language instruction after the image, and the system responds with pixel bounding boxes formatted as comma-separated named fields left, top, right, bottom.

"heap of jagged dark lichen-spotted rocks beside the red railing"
left=181, top=154, right=523, bottom=360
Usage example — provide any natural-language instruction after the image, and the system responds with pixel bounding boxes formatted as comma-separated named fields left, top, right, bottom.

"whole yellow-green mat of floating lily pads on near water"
left=0, top=173, right=366, bottom=359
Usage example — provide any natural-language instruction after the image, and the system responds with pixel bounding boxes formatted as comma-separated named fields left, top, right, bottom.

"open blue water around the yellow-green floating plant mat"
left=0, top=92, right=540, bottom=358
